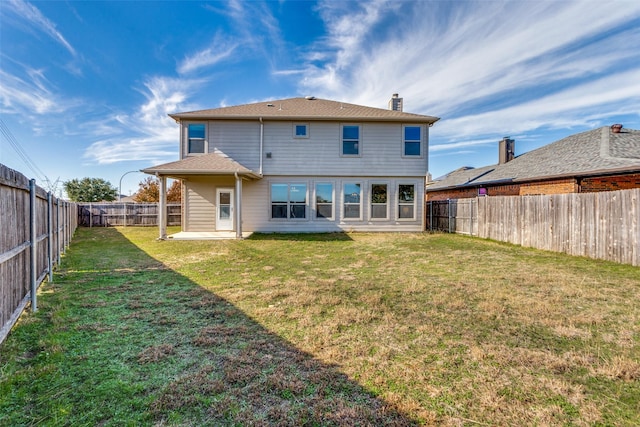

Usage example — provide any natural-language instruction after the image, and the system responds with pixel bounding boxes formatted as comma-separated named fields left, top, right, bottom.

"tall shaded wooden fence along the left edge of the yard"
left=0, top=164, right=78, bottom=343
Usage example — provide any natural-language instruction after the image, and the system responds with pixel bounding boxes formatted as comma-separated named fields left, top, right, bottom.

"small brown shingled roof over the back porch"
left=142, top=149, right=260, bottom=178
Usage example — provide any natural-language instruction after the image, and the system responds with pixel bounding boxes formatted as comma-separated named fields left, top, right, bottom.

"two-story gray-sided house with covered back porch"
left=143, top=94, right=438, bottom=238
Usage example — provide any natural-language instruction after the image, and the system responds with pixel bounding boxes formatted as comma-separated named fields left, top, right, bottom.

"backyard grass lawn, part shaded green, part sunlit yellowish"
left=0, top=228, right=640, bottom=426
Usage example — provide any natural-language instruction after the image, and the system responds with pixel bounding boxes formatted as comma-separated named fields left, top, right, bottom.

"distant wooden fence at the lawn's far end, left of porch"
left=78, top=202, right=182, bottom=227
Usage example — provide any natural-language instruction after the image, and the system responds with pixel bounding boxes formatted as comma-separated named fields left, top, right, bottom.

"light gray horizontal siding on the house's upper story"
left=182, top=120, right=429, bottom=177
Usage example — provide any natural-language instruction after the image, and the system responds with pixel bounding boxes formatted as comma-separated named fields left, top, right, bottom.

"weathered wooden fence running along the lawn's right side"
left=426, top=189, right=640, bottom=266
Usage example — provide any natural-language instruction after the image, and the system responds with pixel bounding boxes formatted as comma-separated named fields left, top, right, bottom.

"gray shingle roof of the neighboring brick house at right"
left=427, top=126, right=640, bottom=191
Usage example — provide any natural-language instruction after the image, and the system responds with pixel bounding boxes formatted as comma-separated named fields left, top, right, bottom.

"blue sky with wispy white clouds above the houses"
left=0, top=0, right=640, bottom=194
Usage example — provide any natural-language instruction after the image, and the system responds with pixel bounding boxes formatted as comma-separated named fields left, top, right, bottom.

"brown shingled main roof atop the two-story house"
left=169, top=97, right=440, bottom=125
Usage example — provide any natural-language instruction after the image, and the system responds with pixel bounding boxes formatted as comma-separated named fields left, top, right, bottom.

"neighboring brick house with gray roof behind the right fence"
left=426, top=125, right=640, bottom=201
